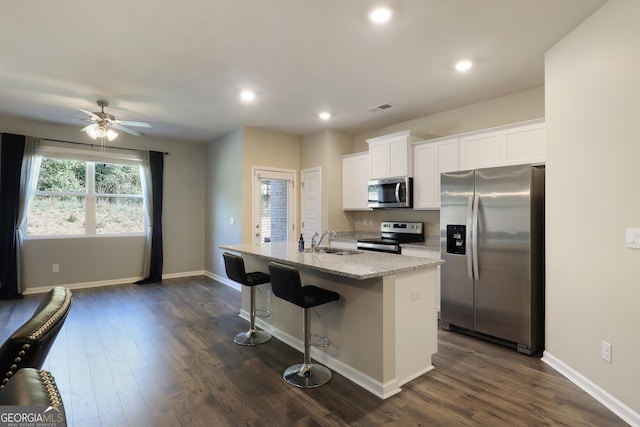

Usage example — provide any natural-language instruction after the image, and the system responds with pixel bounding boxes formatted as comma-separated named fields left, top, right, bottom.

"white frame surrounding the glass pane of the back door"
left=251, top=165, right=297, bottom=245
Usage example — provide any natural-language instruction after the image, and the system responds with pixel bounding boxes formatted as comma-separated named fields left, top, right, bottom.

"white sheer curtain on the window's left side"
left=16, top=136, right=42, bottom=293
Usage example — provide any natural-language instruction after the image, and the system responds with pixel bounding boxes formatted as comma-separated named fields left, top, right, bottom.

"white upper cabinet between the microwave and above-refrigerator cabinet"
left=413, top=138, right=458, bottom=209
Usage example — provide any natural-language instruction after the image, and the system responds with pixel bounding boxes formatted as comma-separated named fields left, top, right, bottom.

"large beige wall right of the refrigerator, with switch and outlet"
left=545, top=0, right=640, bottom=414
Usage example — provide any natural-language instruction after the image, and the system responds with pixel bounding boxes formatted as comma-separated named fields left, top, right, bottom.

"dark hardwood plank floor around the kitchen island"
left=0, top=277, right=626, bottom=427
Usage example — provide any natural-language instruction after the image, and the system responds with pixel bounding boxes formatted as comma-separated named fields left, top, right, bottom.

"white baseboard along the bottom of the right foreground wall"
left=541, top=351, right=640, bottom=427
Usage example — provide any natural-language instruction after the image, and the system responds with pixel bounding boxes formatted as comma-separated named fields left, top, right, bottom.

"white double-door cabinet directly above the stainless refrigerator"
left=460, top=120, right=545, bottom=170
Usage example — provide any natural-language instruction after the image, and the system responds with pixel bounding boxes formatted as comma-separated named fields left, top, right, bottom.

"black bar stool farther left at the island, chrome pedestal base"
left=222, top=252, right=271, bottom=345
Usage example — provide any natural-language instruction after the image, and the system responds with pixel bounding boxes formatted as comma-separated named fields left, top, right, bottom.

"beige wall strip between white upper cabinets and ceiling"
left=354, top=87, right=544, bottom=152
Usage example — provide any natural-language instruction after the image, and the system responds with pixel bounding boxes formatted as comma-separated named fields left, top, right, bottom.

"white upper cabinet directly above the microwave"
left=367, top=130, right=426, bottom=179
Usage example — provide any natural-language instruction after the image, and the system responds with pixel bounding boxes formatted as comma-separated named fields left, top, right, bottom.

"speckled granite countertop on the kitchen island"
left=220, top=242, right=444, bottom=280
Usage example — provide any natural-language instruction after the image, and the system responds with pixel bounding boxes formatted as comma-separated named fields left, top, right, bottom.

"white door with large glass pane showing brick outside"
left=251, top=166, right=296, bottom=244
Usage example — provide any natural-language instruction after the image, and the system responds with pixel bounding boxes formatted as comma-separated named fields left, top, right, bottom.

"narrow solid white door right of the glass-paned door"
left=300, top=167, right=324, bottom=245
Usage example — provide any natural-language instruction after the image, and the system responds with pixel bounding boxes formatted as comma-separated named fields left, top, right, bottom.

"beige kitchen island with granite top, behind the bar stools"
left=220, top=243, right=442, bottom=399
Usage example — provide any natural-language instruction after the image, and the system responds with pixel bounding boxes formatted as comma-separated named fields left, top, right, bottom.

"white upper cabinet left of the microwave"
left=342, top=151, right=369, bottom=211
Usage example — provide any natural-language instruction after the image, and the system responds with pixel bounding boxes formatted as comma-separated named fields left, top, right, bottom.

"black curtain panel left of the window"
left=0, top=133, right=26, bottom=299
